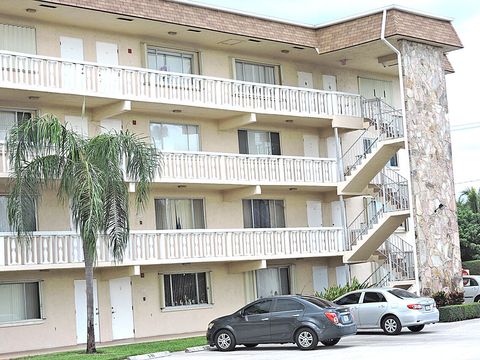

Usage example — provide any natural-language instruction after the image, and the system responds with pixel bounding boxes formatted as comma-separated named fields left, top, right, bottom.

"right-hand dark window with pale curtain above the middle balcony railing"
left=238, top=130, right=281, bottom=155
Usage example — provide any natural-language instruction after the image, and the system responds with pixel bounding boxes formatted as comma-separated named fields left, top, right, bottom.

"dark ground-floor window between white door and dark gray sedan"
left=163, top=272, right=210, bottom=307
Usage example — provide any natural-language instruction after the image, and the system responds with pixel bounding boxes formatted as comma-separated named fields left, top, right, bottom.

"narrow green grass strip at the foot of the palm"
left=24, top=336, right=207, bottom=360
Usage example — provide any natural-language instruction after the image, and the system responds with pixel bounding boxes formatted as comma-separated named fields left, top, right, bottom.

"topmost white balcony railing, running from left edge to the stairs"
left=0, top=51, right=361, bottom=118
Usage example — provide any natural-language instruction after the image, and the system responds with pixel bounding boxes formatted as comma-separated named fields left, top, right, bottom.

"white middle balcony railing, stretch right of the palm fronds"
left=157, top=152, right=337, bottom=186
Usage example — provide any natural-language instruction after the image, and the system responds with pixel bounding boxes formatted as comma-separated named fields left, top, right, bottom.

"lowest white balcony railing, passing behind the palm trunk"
left=0, top=228, right=345, bottom=271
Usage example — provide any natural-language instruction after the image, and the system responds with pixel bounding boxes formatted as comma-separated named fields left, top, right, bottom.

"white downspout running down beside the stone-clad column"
left=380, top=9, right=420, bottom=294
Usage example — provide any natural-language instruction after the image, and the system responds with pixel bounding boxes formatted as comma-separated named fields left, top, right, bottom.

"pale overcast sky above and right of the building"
left=189, top=0, right=480, bottom=194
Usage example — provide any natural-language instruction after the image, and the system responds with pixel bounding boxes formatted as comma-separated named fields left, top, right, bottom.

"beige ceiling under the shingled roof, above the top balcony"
left=1, top=0, right=397, bottom=75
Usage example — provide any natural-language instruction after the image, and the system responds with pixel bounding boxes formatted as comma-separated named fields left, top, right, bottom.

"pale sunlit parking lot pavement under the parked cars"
left=167, top=319, right=480, bottom=360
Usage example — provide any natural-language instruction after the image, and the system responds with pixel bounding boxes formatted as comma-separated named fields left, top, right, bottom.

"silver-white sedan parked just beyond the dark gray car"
left=334, top=288, right=439, bottom=335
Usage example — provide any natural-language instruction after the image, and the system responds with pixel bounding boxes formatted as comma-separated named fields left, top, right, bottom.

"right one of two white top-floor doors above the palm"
left=96, top=41, right=119, bottom=94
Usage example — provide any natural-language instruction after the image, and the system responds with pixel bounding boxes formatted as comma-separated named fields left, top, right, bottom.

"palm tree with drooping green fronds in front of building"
left=7, top=115, right=158, bottom=353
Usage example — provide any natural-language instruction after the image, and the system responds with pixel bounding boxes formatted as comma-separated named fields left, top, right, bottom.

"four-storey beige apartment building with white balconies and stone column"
left=0, top=0, right=462, bottom=353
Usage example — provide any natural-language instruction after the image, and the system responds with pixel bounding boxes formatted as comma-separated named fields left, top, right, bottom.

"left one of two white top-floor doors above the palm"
left=60, top=36, right=85, bottom=90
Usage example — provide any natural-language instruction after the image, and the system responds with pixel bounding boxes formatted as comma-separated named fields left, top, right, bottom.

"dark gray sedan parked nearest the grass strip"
left=207, top=296, right=357, bottom=351
